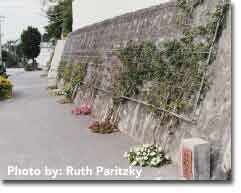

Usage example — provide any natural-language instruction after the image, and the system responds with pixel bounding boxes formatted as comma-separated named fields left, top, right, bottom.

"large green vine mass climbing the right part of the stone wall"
left=113, top=0, right=229, bottom=122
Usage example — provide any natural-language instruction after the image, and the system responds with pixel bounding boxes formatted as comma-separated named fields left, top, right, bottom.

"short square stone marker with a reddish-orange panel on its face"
left=181, top=138, right=210, bottom=180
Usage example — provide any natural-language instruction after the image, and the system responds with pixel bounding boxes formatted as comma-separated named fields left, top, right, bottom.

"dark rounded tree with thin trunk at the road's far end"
left=21, top=26, right=41, bottom=70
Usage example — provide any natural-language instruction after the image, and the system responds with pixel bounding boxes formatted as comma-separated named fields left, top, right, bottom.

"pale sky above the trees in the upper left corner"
left=0, top=0, right=48, bottom=43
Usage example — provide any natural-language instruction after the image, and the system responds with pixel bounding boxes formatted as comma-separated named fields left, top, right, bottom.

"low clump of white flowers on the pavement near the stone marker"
left=124, top=144, right=171, bottom=167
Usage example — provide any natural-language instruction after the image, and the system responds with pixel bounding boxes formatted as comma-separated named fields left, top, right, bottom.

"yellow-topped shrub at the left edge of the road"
left=0, top=76, right=12, bottom=100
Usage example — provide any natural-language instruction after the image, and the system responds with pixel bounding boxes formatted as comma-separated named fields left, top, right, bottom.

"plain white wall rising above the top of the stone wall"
left=73, top=0, right=168, bottom=30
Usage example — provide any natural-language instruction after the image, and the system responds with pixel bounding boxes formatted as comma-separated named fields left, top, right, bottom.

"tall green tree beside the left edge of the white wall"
left=45, top=0, right=73, bottom=39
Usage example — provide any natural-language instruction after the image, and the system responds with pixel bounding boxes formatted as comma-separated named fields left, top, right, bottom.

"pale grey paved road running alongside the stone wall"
left=0, top=70, right=176, bottom=180
